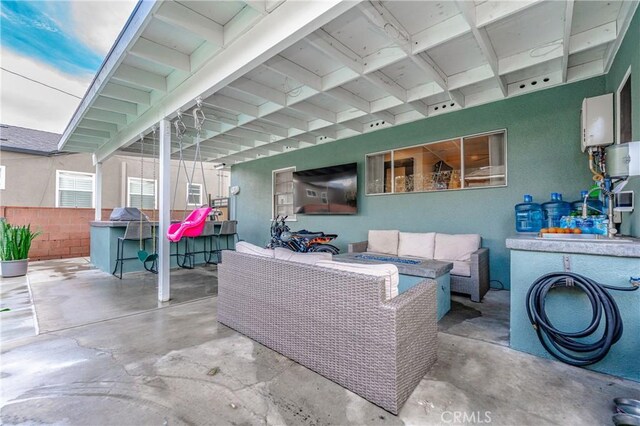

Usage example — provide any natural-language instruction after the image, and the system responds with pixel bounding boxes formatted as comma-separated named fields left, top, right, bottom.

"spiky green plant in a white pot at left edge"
left=0, top=220, right=41, bottom=277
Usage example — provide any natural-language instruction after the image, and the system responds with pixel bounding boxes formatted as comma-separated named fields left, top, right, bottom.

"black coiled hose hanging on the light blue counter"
left=527, top=272, right=638, bottom=366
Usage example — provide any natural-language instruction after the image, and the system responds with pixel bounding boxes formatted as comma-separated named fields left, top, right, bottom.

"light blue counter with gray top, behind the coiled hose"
left=506, top=234, right=640, bottom=381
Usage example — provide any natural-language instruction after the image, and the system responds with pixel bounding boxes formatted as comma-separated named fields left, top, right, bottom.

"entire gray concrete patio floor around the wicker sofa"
left=0, top=259, right=640, bottom=425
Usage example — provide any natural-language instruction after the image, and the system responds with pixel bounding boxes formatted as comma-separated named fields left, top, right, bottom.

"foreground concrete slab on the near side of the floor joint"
left=0, top=258, right=640, bottom=425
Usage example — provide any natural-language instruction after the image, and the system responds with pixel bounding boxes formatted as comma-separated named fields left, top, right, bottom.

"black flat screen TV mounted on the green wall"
left=293, top=163, right=358, bottom=214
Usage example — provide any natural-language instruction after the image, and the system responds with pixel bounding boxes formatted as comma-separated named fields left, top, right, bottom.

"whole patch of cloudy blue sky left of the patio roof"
left=0, top=0, right=136, bottom=133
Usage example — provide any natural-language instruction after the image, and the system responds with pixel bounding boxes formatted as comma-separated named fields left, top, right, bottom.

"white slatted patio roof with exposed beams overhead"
left=59, top=0, right=638, bottom=165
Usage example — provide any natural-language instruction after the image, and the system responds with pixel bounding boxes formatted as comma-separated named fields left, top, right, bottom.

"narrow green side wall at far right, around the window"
left=605, top=7, right=640, bottom=236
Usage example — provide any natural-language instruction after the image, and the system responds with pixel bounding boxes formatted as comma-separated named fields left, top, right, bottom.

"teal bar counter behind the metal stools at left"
left=89, top=221, right=225, bottom=273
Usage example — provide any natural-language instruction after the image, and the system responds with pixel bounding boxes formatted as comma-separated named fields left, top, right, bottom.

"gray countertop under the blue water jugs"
left=506, top=234, right=640, bottom=258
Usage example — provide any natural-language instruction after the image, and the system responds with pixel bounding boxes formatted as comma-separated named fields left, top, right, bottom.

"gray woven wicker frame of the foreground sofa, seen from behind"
left=217, top=251, right=437, bottom=414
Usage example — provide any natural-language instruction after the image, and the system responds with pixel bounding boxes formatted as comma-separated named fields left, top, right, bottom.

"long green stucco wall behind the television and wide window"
left=231, top=77, right=605, bottom=288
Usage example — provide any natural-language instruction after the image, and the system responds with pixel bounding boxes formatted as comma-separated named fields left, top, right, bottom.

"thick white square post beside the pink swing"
left=157, top=119, right=171, bottom=302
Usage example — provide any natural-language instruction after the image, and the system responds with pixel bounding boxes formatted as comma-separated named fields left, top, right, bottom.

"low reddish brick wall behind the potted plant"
left=0, top=206, right=200, bottom=260
